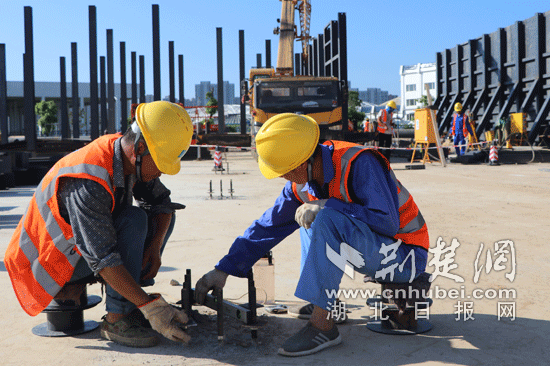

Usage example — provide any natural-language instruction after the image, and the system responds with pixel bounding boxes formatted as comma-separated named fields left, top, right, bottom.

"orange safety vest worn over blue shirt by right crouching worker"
left=292, top=141, right=430, bottom=250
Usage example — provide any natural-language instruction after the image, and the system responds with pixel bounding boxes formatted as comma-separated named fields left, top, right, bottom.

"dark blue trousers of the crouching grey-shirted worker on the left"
left=70, top=206, right=176, bottom=314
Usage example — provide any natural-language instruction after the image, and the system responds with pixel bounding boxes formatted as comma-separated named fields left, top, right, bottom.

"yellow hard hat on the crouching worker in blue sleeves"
left=256, top=113, right=320, bottom=179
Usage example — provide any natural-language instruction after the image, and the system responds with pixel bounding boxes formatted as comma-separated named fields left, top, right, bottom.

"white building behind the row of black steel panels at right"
left=399, top=63, right=437, bottom=121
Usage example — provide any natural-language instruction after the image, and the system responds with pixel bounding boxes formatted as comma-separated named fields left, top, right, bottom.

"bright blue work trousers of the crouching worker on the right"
left=295, top=208, right=426, bottom=311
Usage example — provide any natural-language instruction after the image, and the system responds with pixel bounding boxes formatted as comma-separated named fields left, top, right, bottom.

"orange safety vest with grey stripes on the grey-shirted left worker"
left=4, top=134, right=121, bottom=316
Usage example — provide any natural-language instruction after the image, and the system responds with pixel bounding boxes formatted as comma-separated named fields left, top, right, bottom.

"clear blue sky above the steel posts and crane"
left=0, top=0, right=550, bottom=98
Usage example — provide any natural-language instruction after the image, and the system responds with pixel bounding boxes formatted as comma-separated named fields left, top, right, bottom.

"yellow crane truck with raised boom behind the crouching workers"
left=246, top=0, right=343, bottom=137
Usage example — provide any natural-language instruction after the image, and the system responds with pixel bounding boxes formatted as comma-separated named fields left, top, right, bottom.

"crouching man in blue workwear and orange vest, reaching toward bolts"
left=195, top=113, right=429, bottom=356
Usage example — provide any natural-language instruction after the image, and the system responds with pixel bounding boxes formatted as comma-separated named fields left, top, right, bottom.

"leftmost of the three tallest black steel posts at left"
left=23, top=6, right=36, bottom=151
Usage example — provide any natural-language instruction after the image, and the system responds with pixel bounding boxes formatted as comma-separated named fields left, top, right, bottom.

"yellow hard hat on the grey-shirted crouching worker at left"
left=136, top=101, right=193, bottom=175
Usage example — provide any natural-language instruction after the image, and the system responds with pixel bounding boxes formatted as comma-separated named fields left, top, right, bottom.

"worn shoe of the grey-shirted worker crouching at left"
left=100, top=317, right=159, bottom=348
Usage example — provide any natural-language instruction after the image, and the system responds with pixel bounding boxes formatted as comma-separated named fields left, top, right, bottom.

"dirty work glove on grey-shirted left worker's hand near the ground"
left=139, top=294, right=191, bottom=343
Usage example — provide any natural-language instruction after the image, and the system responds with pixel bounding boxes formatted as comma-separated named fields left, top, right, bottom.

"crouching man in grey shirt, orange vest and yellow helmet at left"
left=4, top=101, right=193, bottom=347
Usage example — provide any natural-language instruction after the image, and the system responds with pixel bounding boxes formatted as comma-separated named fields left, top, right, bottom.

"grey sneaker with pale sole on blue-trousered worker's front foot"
left=279, top=322, right=342, bottom=357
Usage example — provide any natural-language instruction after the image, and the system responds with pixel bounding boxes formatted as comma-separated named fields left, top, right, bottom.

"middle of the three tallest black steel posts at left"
left=88, top=5, right=99, bottom=140
